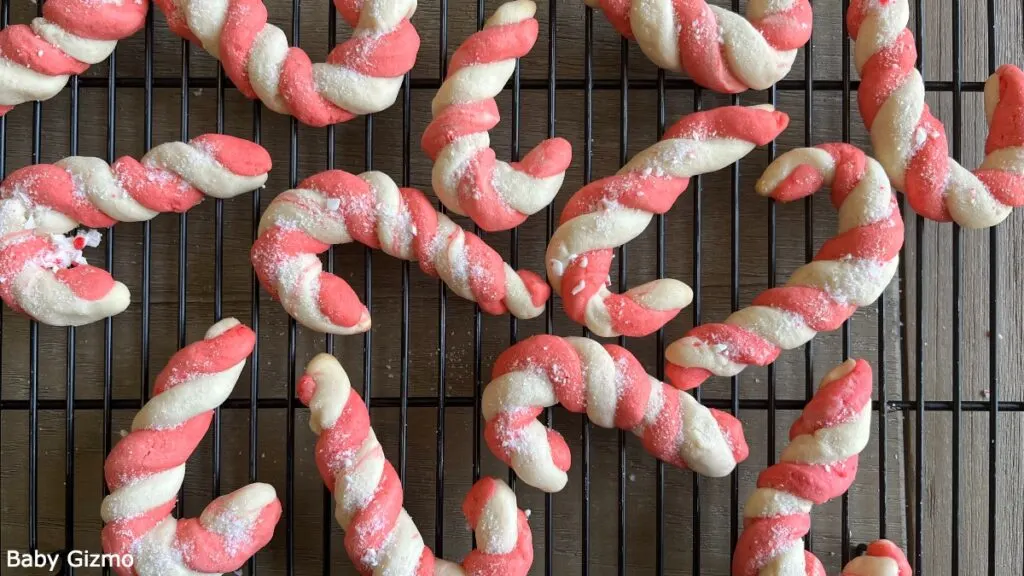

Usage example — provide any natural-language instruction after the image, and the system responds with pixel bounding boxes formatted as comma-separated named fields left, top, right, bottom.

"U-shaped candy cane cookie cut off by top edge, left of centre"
left=156, top=0, right=420, bottom=126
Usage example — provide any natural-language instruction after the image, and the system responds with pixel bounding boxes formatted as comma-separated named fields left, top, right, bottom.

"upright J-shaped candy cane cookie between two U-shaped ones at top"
left=422, top=0, right=572, bottom=232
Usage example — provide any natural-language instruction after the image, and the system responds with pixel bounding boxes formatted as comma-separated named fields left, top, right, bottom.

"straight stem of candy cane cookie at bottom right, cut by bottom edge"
left=732, top=360, right=872, bottom=576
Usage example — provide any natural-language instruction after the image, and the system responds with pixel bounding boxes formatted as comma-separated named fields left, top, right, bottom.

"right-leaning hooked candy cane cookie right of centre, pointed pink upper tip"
left=545, top=105, right=790, bottom=336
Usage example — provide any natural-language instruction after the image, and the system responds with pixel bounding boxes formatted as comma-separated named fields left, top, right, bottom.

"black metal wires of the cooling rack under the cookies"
left=0, top=0, right=1024, bottom=575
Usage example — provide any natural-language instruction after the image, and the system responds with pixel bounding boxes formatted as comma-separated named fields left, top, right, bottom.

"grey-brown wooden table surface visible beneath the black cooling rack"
left=0, top=0, right=1024, bottom=575
